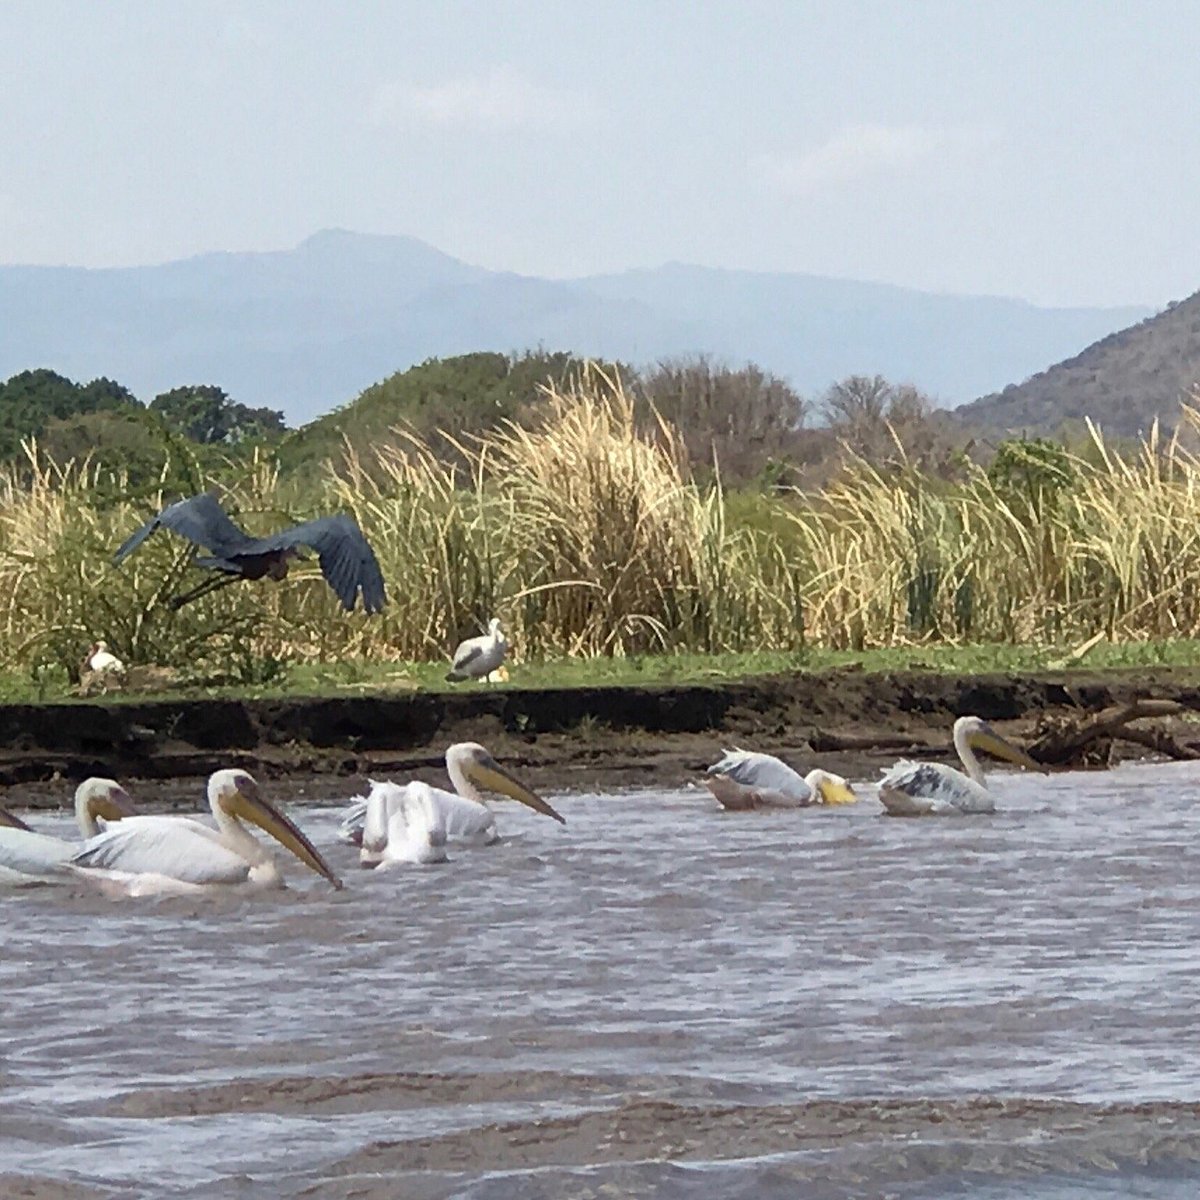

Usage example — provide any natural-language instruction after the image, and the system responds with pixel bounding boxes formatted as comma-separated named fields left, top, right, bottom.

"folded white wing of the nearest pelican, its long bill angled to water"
left=71, top=816, right=251, bottom=884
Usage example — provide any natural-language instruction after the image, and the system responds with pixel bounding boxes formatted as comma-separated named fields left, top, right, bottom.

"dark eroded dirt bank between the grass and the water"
left=0, top=668, right=1200, bottom=804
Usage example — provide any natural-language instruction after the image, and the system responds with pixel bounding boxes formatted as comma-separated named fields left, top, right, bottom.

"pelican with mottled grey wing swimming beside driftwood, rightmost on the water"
left=880, top=716, right=1046, bottom=817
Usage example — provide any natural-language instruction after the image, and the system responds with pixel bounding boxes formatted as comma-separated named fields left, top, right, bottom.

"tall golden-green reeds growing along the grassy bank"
left=0, top=371, right=1200, bottom=683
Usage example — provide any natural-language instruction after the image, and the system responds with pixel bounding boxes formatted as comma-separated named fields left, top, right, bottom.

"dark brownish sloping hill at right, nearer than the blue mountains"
left=958, top=293, right=1200, bottom=437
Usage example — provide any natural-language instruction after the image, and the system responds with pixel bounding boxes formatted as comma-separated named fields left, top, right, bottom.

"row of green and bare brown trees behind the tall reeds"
left=0, top=350, right=964, bottom=486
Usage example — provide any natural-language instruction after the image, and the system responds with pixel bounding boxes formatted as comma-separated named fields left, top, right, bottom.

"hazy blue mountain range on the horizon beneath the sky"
left=0, top=230, right=1165, bottom=424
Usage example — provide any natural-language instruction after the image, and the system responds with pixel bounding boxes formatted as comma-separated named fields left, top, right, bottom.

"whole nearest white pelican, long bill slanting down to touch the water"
left=71, top=770, right=342, bottom=895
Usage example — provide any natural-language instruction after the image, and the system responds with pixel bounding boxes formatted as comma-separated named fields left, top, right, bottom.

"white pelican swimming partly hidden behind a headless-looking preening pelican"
left=337, top=742, right=566, bottom=866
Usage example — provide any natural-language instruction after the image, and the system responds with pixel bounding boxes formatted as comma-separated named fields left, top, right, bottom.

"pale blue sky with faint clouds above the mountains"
left=0, top=0, right=1200, bottom=307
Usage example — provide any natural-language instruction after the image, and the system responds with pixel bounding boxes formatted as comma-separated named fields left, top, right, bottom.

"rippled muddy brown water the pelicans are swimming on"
left=0, top=766, right=1200, bottom=1200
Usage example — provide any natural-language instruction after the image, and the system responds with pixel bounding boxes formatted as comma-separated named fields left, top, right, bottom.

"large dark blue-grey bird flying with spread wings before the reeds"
left=113, top=492, right=386, bottom=612
